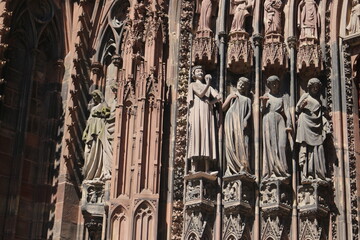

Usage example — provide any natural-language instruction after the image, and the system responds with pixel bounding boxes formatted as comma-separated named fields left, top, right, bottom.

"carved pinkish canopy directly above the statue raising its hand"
left=193, top=30, right=217, bottom=69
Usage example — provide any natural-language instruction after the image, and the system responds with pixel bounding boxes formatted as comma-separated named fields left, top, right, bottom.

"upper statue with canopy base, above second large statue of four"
left=227, top=0, right=254, bottom=74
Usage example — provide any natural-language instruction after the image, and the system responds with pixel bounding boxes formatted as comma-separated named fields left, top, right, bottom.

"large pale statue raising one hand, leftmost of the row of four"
left=187, top=66, right=221, bottom=172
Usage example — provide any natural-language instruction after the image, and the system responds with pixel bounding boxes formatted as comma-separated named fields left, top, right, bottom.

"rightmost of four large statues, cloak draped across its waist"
left=296, top=78, right=329, bottom=182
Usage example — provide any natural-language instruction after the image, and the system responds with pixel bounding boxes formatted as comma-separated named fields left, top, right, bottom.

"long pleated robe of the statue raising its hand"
left=187, top=81, right=218, bottom=160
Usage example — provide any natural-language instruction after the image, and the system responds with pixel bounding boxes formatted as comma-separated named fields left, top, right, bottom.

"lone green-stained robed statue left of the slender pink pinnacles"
left=82, top=90, right=109, bottom=180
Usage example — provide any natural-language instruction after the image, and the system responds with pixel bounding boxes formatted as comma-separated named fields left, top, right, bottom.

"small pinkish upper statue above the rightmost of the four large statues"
left=297, top=0, right=320, bottom=40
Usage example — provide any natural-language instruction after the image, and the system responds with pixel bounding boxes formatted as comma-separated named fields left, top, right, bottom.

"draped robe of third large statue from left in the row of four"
left=262, top=93, right=289, bottom=178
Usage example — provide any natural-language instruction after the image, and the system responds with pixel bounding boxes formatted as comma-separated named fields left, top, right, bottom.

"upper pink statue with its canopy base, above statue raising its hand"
left=192, top=0, right=217, bottom=68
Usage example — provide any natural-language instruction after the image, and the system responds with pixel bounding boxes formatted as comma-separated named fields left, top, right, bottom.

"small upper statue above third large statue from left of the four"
left=264, top=0, right=283, bottom=35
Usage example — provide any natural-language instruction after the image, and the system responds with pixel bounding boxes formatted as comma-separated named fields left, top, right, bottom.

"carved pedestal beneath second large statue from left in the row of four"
left=222, top=174, right=255, bottom=239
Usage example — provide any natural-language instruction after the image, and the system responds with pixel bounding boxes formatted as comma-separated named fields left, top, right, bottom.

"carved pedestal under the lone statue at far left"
left=81, top=180, right=106, bottom=240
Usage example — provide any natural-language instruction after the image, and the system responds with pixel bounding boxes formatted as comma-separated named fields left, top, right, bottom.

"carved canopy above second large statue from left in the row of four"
left=227, top=32, right=253, bottom=74
